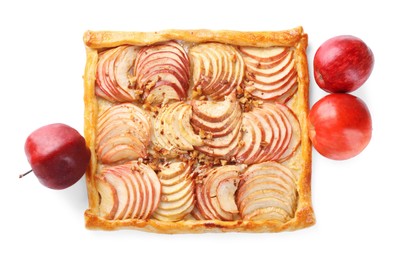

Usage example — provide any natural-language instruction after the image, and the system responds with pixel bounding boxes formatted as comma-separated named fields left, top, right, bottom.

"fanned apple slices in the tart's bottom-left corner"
left=95, top=161, right=161, bottom=219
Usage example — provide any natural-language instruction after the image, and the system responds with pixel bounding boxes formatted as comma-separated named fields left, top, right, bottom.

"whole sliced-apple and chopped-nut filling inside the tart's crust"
left=95, top=41, right=301, bottom=222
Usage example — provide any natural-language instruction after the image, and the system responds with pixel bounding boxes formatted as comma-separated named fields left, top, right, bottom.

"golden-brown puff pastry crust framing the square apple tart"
left=84, top=27, right=315, bottom=233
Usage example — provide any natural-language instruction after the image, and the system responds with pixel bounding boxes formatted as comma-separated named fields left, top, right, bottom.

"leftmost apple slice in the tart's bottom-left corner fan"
left=95, top=175, right=119, bottom=219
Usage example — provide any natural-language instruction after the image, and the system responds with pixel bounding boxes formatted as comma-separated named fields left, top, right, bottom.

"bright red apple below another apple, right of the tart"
left=309, top=93, right=372, bottom=160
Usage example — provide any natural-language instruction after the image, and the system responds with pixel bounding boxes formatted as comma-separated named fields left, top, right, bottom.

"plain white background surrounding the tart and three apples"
left=0, top=0, right=397, bottom=259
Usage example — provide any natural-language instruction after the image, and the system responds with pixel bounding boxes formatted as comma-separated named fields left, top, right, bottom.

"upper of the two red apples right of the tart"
left=313, top=35, right=374, bottom=93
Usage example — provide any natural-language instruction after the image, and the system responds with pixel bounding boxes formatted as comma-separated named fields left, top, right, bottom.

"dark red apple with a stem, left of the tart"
left=25, top=123, right=91, bottom=190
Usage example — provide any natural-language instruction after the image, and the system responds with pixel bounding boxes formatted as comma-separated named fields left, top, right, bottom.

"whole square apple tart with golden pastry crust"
left=84, top=27, right=315, bottom=233
